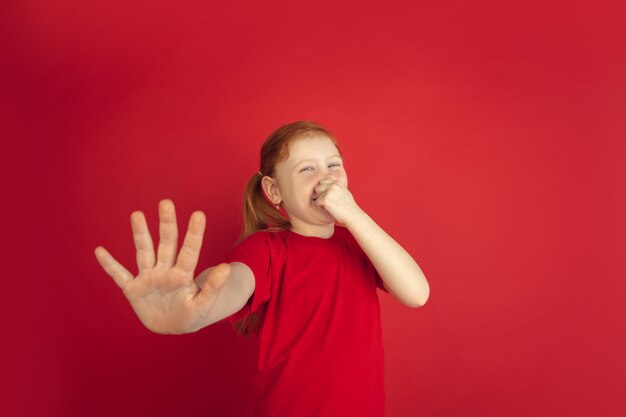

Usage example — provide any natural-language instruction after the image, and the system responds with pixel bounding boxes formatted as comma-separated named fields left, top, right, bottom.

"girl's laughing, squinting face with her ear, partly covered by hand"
left=264, top=135, right=348, bottom=226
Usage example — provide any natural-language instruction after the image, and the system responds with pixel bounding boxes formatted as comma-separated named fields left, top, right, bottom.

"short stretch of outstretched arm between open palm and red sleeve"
left=195, top=262, right=255, bottom=326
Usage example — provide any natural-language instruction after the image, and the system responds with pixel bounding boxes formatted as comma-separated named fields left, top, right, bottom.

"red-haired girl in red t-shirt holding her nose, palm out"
left=95, top=121, right=430, bottom=417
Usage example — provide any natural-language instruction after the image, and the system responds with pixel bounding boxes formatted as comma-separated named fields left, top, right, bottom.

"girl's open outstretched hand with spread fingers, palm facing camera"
left=95, top=199, right=231, bottom=334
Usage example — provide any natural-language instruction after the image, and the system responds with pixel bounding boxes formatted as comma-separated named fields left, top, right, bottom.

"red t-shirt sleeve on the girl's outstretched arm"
left=224, top=231, right=271, bottom=322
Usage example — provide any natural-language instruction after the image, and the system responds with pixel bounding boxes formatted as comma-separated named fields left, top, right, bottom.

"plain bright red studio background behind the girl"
left=0, top=0, right=626, bottom=417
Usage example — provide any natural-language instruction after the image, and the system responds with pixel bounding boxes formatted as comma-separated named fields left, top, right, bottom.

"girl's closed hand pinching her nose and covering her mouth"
left=313, top=178, right=361, bottom=225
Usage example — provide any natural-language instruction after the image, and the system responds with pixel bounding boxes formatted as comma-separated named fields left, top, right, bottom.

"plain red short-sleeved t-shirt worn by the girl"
left=219, top=226, right=385, bottom=417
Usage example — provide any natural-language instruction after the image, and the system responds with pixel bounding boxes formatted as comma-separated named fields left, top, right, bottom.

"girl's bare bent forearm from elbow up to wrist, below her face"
left=346, top=209, right=430, bottom=307
